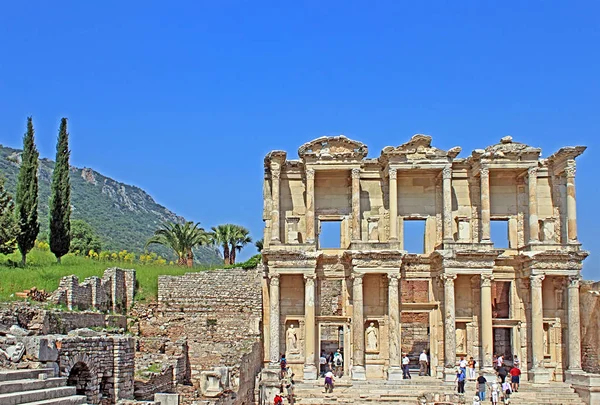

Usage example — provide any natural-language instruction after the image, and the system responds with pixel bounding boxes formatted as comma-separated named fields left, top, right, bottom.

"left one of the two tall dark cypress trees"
left=16, top=117, right=40, bottom=266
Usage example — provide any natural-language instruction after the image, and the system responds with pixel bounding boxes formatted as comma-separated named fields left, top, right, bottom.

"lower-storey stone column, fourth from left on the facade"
left=388, top=274, right=402, bottom=380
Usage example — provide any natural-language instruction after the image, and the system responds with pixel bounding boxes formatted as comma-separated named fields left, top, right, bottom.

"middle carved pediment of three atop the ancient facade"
left=381, top=134, right=462, bottom=161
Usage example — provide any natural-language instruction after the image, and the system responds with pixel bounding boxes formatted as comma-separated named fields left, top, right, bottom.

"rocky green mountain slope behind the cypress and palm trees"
left=0, top=145, right=223, bottom=264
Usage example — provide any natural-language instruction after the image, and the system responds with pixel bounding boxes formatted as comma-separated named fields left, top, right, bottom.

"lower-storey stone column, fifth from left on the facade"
left=441, top=274, right=456, bottom=381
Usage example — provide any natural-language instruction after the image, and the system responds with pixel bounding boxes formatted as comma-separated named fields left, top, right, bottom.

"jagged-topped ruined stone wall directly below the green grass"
left=50, top=267, right=135, bottom=312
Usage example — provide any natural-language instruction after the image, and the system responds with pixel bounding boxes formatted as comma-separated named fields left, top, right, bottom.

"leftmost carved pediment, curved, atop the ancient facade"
left=298, top=135, right=368, bottom=160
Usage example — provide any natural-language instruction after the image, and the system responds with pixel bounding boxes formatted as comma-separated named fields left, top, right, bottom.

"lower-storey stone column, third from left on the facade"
left=352, top=273, right=367, bottom=380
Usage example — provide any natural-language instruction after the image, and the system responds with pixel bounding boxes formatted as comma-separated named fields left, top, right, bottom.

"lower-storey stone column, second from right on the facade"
left=529, top=274, right=549, bottom=383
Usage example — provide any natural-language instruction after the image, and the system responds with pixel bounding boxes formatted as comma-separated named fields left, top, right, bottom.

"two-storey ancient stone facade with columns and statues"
left=262, top=135, right=588, bottom=382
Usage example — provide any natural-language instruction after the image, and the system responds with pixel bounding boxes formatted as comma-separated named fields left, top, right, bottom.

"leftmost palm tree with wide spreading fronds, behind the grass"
left=146, top=221, right=210, bottom=267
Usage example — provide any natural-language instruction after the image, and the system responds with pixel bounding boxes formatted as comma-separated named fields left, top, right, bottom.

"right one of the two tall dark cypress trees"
left=48, top=118, right=71, bottom=263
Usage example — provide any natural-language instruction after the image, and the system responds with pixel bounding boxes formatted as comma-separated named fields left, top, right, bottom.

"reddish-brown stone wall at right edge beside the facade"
left=579, top=281, right=600, bottom=374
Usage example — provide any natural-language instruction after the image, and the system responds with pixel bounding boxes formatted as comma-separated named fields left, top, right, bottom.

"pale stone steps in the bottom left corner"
left=0, top=369, right=86, bottom=405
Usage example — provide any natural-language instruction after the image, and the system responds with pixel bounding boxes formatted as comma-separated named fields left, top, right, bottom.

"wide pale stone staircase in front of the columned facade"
left=285, top=377, right=584, bottom=405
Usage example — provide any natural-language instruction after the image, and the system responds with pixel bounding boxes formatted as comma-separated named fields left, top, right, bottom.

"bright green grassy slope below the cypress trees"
left=0, top=248, right=216, bottom=301
